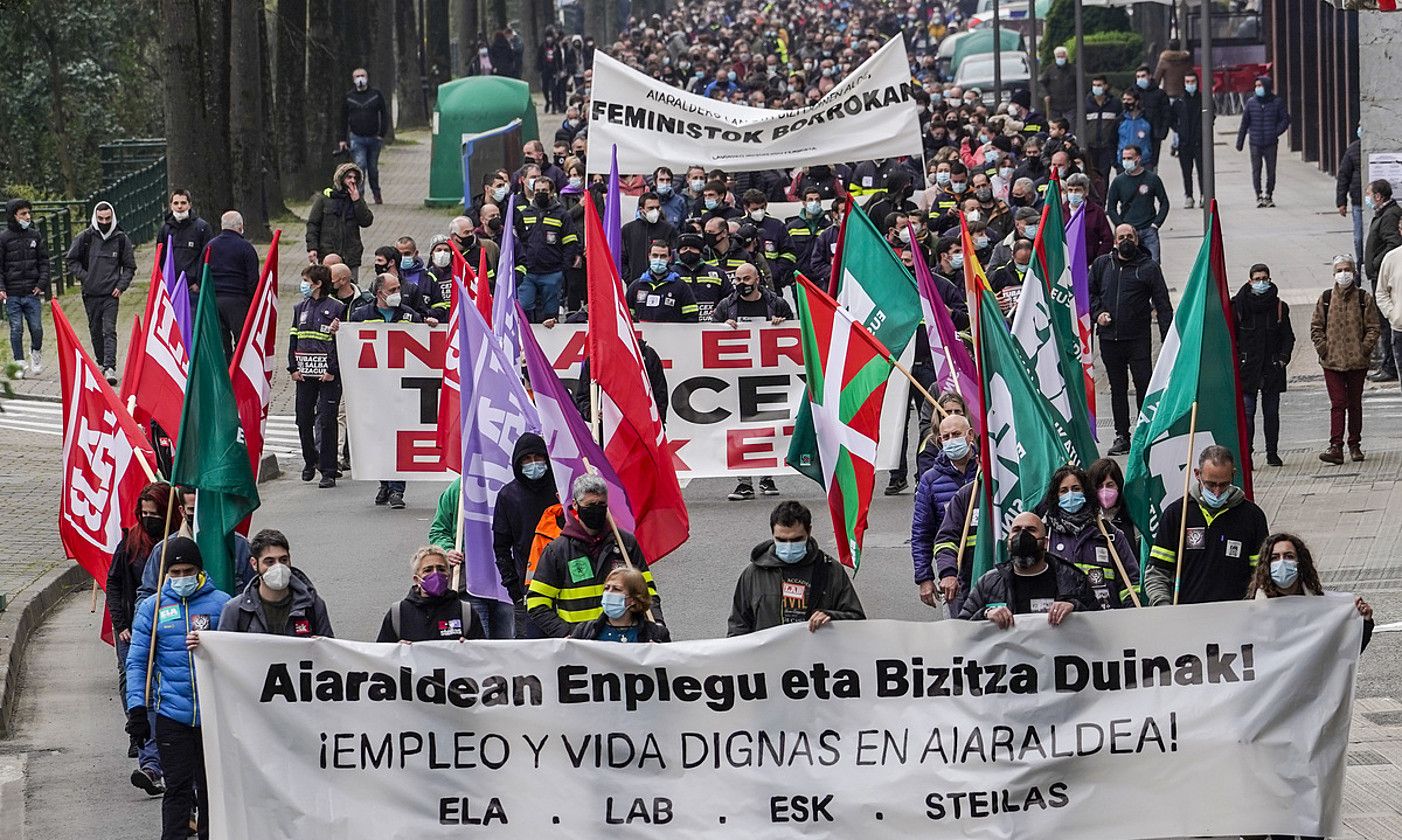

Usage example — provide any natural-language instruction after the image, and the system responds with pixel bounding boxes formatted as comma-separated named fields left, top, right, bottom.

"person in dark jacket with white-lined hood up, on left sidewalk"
left=67, top=202, right=136, bottom=384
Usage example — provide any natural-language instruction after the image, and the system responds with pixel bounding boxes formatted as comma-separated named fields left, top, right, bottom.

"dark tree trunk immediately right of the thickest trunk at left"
left=227, top=0, right=271, bottom=240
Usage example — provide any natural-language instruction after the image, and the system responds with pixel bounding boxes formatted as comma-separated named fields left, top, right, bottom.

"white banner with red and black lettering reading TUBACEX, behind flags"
left=336, top=321, right=914, bottom=481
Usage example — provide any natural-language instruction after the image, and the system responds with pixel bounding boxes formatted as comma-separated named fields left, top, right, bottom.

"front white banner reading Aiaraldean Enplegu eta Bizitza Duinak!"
left=195, top=597, right=1361, bottom=840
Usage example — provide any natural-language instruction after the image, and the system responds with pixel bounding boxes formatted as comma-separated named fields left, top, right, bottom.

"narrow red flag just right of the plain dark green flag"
left=229, top=230, right=282, bottom=485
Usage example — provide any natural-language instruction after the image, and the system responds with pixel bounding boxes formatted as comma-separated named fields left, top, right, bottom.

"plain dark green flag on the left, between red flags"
left=171, top=265, right=259, bottom=593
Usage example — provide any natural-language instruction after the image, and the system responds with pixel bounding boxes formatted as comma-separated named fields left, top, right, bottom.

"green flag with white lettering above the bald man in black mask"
left=972, top=287, right=1075, bottom=581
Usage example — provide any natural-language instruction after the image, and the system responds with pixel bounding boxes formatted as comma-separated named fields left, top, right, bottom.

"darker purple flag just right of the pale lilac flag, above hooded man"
left=522, top=307, right=635, bottom=531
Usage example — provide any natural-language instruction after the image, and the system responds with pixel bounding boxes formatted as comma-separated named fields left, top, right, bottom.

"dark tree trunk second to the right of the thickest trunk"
left=272, top=0, right=311, bottom=198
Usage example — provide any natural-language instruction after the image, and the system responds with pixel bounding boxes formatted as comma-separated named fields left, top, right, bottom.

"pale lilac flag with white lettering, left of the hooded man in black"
left=457, top=283, right=540, bottom=603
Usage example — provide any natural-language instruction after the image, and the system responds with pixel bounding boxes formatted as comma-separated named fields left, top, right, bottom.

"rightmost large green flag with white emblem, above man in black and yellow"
left=1124, top=202, right=1252, bottom=557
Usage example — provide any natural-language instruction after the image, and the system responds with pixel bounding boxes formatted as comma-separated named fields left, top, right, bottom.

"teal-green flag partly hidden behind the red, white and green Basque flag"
left=788, top=204, right=923, bottom=487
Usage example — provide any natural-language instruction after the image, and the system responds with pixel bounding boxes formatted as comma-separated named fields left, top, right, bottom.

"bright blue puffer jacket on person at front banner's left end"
left=126, top=578, right=229, bottom=726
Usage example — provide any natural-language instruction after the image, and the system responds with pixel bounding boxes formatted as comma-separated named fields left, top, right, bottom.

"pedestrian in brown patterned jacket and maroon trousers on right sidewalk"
left=1309, top=254, right=1378, bottom=464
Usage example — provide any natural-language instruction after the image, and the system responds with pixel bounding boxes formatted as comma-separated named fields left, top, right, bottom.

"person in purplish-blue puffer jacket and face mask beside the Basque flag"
left=910, top=414, right=979, bottom=607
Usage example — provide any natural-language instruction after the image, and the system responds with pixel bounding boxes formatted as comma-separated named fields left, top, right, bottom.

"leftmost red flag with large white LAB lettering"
left=49, top=300, right=156, bottom=644
